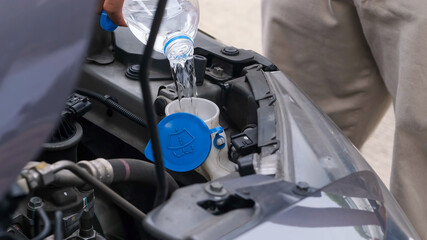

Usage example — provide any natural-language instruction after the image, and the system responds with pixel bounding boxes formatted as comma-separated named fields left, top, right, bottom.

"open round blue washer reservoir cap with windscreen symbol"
left=144, top=113, right=214, bottom=172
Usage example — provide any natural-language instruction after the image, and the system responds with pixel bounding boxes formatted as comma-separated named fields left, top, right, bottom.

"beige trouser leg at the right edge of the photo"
left=354, top=0, right=427, bottom=236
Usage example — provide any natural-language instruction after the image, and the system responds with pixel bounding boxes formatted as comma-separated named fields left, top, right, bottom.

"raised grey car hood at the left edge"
left=0, top=0, right=96, bottom=196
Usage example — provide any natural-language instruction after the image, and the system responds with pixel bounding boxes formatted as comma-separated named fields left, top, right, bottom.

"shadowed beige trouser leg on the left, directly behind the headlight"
left=262, top=0, right=390, bottom=147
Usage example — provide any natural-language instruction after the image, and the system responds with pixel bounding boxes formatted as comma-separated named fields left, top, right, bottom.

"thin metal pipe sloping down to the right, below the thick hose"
left=52, top=160, right=145, bottom=220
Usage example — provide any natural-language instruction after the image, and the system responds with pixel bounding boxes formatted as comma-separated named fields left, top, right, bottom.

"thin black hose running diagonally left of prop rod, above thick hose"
left=75, top=88, right=147, bottom=127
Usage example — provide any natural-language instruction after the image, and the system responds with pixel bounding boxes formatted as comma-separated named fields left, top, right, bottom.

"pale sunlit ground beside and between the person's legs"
left=199, top=0, right=395, bottom=186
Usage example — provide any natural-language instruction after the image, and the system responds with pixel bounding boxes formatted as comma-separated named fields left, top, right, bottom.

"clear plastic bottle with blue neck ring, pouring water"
left=123, top=0, right=199, bottom=99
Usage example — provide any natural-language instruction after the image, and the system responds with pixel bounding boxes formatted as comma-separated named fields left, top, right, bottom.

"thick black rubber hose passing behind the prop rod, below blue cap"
left=108, top=159, right=178, bottom=195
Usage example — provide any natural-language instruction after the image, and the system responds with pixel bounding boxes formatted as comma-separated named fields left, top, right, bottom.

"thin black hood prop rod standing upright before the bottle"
left=139, top=0, right=168, bottom=207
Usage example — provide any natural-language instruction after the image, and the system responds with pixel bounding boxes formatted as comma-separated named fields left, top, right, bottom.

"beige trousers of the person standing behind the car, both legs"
left=262, top=0, right=427, bottom=239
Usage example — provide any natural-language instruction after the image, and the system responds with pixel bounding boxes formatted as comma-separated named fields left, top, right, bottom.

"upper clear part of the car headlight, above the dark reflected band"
left=265, top=72, right=374, bottom=188
